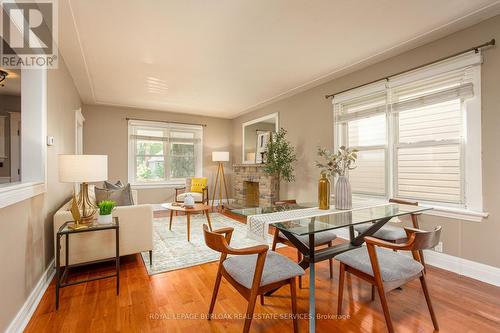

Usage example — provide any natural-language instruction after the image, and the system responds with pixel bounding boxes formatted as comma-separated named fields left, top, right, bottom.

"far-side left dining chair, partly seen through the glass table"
left=271, top=200, right=337, bottom=288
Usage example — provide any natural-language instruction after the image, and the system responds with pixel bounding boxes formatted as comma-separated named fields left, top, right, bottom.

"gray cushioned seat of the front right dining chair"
left=335, top=246, right=424, bottom=282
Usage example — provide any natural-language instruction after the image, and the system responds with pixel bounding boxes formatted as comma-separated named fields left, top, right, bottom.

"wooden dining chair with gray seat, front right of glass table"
left=335, top=227, right=441, bottom=333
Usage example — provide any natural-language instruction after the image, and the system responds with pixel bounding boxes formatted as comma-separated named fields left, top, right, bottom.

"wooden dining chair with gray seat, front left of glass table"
left=203, top=224, right=304, bottom=333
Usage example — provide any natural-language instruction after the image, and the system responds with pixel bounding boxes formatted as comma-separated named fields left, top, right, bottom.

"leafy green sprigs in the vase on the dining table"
left=316, top=146, right=358, bottom=177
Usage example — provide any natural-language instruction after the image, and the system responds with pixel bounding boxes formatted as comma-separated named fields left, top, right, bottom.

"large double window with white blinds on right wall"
left=333, top=52, right=482, bottom=211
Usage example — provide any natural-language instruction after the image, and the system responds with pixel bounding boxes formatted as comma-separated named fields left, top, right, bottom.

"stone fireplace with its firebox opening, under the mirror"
left=233, top=164, right=277, bottom=207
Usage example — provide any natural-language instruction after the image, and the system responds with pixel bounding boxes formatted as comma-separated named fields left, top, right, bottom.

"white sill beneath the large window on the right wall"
left=353, top=195, right=489, bottom=222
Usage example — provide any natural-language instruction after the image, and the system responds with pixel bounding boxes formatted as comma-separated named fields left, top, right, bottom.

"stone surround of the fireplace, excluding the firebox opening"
left=233, top=164, right=277, bottom=206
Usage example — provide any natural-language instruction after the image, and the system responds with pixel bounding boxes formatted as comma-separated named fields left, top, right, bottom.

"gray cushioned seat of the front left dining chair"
left=223, top=251, right=304, bottom=289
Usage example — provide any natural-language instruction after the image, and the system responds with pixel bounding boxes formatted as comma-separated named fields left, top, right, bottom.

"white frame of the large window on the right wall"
left=332, top=54, right=488, bottom=222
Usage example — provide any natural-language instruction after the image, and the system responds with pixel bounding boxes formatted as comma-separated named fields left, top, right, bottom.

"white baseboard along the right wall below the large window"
left=336, top=228, right=500, bottom=287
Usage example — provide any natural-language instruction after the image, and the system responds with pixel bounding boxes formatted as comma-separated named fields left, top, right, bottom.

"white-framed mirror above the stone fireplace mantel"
left=241, top=113, right=279, bottom=164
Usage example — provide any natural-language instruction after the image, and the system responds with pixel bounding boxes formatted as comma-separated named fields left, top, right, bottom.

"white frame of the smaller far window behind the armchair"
left=127, top=120, right=203, bottom=188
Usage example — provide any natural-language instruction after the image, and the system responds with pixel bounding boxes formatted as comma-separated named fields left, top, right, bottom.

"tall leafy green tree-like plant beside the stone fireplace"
left=264, top=128, right=297, bottom=203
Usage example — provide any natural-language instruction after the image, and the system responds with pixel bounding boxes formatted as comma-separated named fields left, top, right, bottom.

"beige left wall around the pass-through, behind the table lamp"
left=0, top=57, right=80, bottom=331
